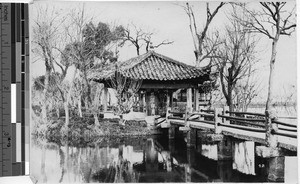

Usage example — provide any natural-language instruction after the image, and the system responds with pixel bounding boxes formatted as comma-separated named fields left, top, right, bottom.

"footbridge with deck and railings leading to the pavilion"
left=157, top=107, right=298, bottom=151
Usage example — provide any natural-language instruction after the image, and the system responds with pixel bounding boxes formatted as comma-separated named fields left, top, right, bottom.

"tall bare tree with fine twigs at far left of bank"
left=33, top=7, right=93, bottom=126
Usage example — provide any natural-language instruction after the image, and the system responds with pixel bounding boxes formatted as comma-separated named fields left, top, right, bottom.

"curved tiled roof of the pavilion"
left=89, top=51, right=206, bottom=80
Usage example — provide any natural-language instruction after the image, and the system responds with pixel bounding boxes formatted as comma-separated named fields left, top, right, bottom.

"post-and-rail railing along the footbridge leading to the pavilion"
left=166, top=107, right=297, bottom=146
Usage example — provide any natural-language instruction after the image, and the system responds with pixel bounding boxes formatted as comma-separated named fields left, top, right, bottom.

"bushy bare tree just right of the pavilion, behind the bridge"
left=213, top=20, right=257, bottom=110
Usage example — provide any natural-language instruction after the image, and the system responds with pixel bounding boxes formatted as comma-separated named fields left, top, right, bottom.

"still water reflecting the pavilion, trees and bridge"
left=30, top=136, right=297, bottom=183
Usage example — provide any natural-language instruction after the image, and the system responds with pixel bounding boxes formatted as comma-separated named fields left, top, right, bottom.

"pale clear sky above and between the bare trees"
left=30, top=1, right=297, bottom=100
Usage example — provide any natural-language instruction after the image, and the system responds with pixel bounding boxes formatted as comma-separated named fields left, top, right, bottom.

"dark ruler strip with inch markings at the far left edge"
left=1, top=3, right=12, bottom=176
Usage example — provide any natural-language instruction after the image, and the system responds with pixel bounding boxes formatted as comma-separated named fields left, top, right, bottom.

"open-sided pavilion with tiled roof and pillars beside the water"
left=89, top=51, right=211, bottom=116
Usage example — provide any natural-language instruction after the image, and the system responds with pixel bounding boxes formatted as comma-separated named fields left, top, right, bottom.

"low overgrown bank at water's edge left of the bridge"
left=32, top=117, right=155, bottom=145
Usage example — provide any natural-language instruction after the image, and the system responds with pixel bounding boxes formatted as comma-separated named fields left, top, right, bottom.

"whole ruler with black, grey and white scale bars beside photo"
left=0, top=3, right=30, bottom=176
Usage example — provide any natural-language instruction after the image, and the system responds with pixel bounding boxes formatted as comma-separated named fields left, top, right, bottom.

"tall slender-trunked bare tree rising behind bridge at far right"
left=234, top=2, right=296, bottom=118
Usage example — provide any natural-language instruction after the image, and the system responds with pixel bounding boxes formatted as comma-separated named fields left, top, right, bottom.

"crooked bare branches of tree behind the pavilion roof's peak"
left=121, top=24, right=173, bottom=55
